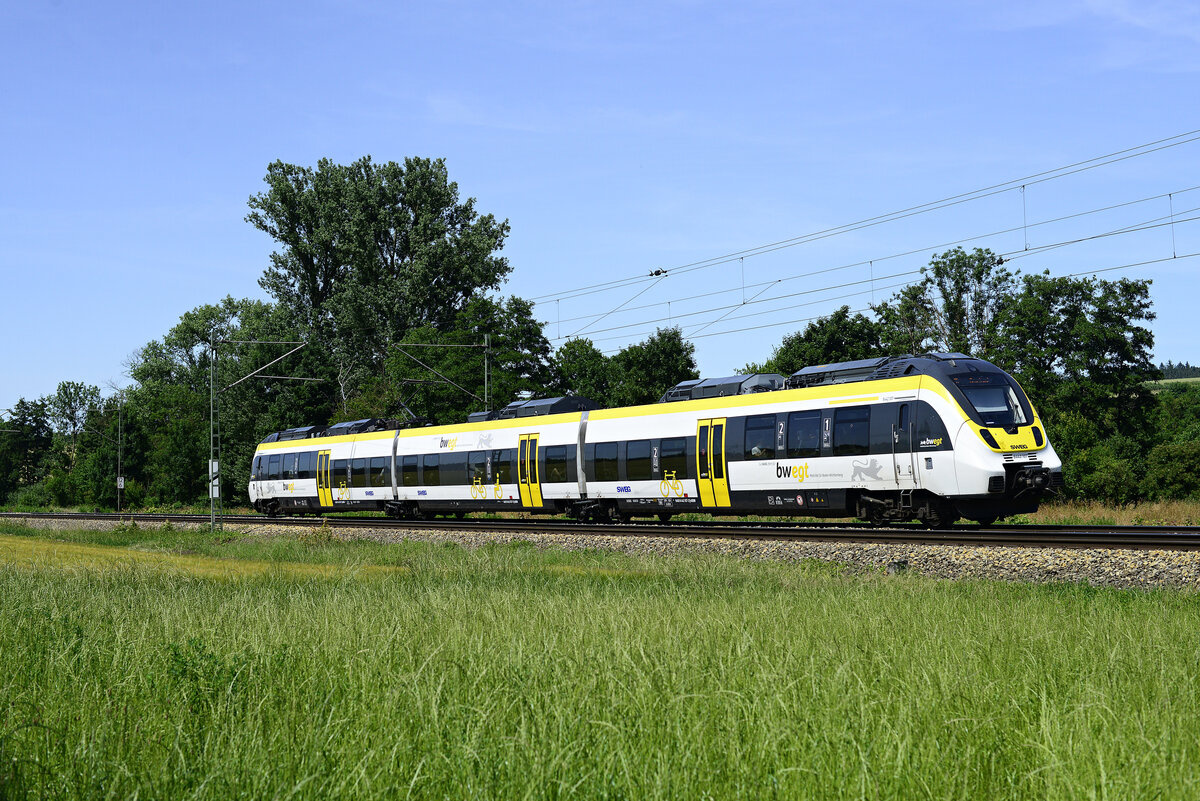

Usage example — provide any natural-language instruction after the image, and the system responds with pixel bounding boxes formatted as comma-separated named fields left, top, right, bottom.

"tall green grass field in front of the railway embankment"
left=0, top=524, right=1200, bottom=799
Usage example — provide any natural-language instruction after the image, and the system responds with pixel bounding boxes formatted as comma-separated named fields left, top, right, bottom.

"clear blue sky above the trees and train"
left=0, top=0, right=1200, bottom=409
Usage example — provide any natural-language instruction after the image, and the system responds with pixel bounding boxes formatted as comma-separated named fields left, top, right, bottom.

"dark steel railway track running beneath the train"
left=7, top=512, right=1200, bottom=550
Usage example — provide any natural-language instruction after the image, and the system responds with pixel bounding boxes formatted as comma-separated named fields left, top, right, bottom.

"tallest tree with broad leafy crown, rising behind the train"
left=246, top=156, right=510, bottom=403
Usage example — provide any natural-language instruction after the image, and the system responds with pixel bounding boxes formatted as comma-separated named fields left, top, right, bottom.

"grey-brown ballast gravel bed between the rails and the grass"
left=9, top=518, right=1200, bottom=589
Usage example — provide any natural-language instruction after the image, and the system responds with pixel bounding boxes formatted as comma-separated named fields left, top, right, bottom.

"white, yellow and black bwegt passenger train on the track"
left=248, top=353, right=1063, bottom=528
